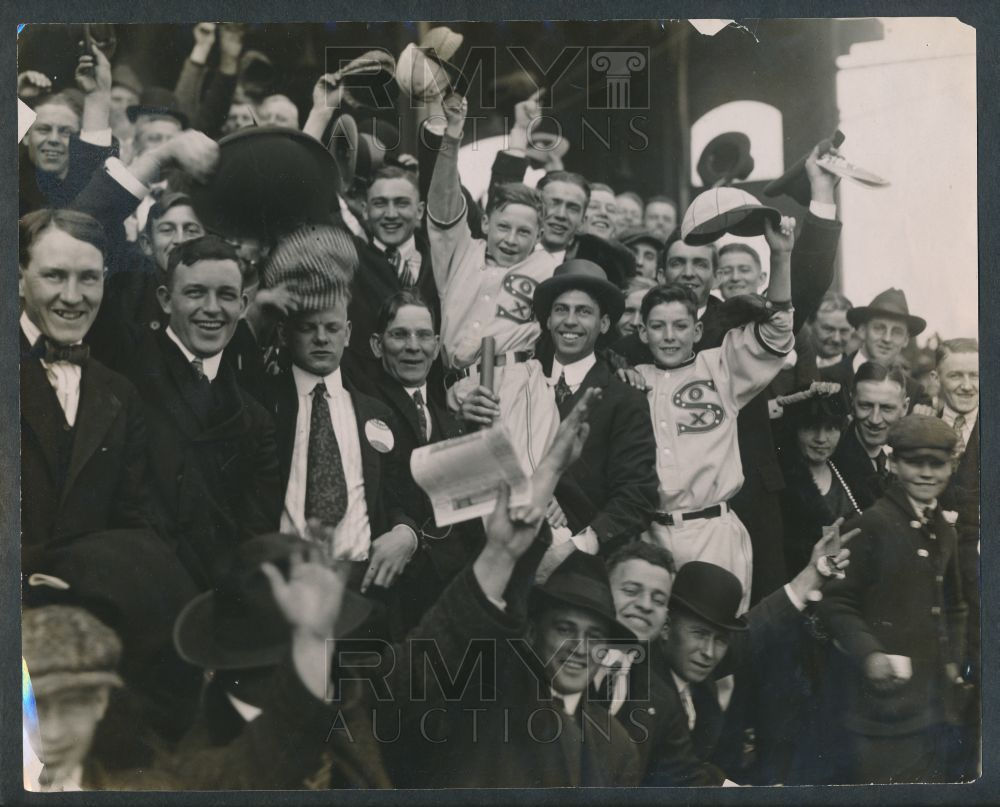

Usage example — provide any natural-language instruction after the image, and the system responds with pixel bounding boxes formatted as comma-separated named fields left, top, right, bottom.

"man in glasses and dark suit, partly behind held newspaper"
left=371, top=290, right=484, bottom=627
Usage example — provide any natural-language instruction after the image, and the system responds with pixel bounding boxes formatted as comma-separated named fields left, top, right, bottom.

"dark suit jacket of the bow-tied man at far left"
left=20, top=334, right=152, bottom=571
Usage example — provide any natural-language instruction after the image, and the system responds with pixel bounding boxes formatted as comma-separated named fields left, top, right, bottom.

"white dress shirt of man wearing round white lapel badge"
left=281, top=366, right=372, bottom=560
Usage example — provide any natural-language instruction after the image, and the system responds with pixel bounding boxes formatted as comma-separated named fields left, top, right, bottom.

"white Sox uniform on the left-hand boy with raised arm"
left=427, top=200, right=559, bottom=471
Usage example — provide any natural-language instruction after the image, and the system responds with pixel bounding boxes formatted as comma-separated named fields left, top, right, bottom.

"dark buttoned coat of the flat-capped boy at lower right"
left=820, top=484, right=966, bottom=736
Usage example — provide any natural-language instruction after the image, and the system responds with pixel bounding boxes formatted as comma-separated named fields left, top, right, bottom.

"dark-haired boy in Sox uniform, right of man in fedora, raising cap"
left=636, top=218, right=795, bottom=613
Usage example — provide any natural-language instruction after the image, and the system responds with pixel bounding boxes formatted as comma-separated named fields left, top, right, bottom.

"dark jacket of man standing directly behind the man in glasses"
left=342, top=230, right=442, bottom=395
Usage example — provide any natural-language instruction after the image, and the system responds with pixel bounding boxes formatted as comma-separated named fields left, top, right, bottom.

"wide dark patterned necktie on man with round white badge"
left=305, top=383, right=347, bottom=527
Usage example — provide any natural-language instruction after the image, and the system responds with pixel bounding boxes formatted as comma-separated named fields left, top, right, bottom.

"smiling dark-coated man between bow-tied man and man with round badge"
left=120, top=236, right=281, bottom=588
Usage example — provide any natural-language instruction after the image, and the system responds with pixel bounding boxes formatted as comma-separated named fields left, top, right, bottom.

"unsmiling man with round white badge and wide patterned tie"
left=269, top=270, right=419, bottom=608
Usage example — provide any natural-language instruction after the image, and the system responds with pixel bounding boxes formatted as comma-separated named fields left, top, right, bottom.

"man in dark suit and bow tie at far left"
left=18, top=210, right=151, bottom=572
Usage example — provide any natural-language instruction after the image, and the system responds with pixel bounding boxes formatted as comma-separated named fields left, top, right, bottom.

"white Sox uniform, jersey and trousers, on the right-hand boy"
left=636, top=311, right=794, bottom=610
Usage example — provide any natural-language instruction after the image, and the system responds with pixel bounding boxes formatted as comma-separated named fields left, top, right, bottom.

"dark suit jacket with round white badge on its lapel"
left=268, top=370, right=419, bottom=540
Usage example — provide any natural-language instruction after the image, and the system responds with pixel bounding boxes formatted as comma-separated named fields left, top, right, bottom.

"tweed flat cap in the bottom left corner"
left=21, top=605, right=122, bottom=698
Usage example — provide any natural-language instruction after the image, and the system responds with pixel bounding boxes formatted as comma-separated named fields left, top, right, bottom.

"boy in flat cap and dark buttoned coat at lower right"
left=821, top=415, right=967, bottom=783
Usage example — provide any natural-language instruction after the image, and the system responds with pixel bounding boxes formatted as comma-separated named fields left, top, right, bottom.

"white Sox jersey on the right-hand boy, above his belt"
left=636, top=311, right=794, bottom=512
